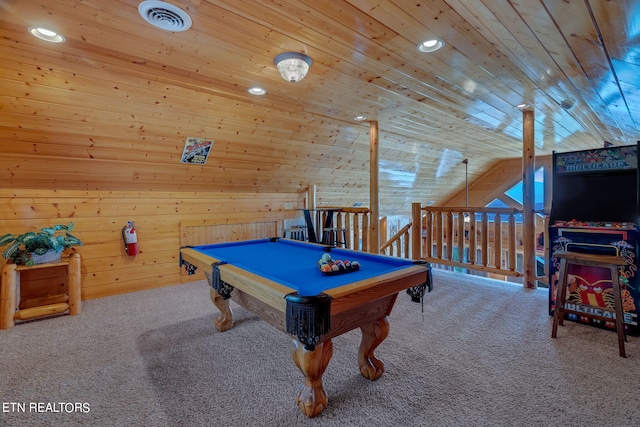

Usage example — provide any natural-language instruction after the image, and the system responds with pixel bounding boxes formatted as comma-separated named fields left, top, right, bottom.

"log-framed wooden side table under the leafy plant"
left=0, top=253, right=81, bottom=329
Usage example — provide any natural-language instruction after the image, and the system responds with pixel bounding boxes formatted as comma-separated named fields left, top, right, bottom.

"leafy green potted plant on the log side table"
left=0, top=222, right=82, bottom=265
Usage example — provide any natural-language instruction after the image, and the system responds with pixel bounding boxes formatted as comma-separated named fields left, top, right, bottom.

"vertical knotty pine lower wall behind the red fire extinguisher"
left=0, top=189, right=305, bottom=299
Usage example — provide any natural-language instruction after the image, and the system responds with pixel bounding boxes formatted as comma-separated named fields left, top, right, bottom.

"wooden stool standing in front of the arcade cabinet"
left=551, top=251, right=627, bottom=357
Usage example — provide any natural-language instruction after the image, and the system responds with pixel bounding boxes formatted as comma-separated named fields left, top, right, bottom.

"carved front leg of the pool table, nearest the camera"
left=291, top=340, right=333, bottom=418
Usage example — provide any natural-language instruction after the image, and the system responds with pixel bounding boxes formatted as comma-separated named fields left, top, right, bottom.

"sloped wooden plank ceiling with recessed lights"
left=0, top=0, right=640, bottom=214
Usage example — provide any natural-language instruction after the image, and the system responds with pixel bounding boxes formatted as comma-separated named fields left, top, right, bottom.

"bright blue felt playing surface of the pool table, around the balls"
left=192, top=238, right=415, bottom=296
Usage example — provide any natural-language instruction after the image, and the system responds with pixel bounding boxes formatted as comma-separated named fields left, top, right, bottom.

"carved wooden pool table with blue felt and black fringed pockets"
left=180, top=238, right=432, bottom=418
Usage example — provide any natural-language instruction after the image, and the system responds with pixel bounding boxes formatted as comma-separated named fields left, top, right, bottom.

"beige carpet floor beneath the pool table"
left=0, top=270, right=640, bottom=427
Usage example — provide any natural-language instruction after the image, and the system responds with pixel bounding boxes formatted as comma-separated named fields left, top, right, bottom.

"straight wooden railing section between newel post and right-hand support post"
left=412, top=204, right=534, bottom=277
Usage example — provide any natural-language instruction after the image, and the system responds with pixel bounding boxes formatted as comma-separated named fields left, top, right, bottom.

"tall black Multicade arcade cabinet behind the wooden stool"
left=549, top=142, right=640, bottom=335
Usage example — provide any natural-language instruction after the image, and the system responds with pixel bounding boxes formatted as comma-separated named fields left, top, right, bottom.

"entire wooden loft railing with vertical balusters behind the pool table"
left=318, top=203, right=548, bottom=282
